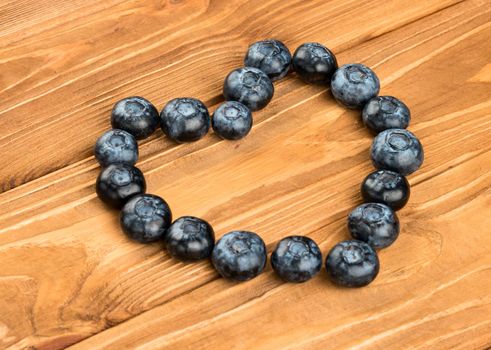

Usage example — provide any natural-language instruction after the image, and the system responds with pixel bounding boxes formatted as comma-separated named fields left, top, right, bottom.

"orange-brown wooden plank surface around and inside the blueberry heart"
left=0, top=0, right=491, bottom=350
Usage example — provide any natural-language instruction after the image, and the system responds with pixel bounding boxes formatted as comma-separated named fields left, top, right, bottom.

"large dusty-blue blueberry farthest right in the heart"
left=370, top=129, right=424, bottom=175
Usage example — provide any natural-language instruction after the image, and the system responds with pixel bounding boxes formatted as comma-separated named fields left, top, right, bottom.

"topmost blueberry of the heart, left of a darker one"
left=244, top=39, right=292, bottom=81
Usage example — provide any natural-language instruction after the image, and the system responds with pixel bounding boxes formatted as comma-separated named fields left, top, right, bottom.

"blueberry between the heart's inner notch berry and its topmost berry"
left=223, top=67, right=274, bottom=111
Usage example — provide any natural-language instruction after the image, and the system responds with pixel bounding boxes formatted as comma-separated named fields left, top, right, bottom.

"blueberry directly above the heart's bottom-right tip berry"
left=348, top=203, right=399, bottom=249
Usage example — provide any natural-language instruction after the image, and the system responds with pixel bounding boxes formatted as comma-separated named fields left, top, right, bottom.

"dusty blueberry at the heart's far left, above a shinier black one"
left=94, top=129, right=138, bottom=167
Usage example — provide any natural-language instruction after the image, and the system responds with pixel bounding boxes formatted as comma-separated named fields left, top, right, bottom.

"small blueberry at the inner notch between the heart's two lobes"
left=211, top=101, right=252, bottom=140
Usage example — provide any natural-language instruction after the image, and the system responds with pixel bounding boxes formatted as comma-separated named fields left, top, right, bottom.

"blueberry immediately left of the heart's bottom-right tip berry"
left=271, top=236, right=322, bottom=283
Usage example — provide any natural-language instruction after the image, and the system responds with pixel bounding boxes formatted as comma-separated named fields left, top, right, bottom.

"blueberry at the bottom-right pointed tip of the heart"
left=326, top=240, right=380, bottom=287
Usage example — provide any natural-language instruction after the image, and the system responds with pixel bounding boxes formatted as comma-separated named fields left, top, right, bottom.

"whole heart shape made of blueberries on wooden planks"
left=94, top=40, right=424, bottom=287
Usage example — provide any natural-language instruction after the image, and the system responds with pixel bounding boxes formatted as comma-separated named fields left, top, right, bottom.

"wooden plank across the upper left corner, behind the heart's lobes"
left=0, top=0, right=462, bottom=191
